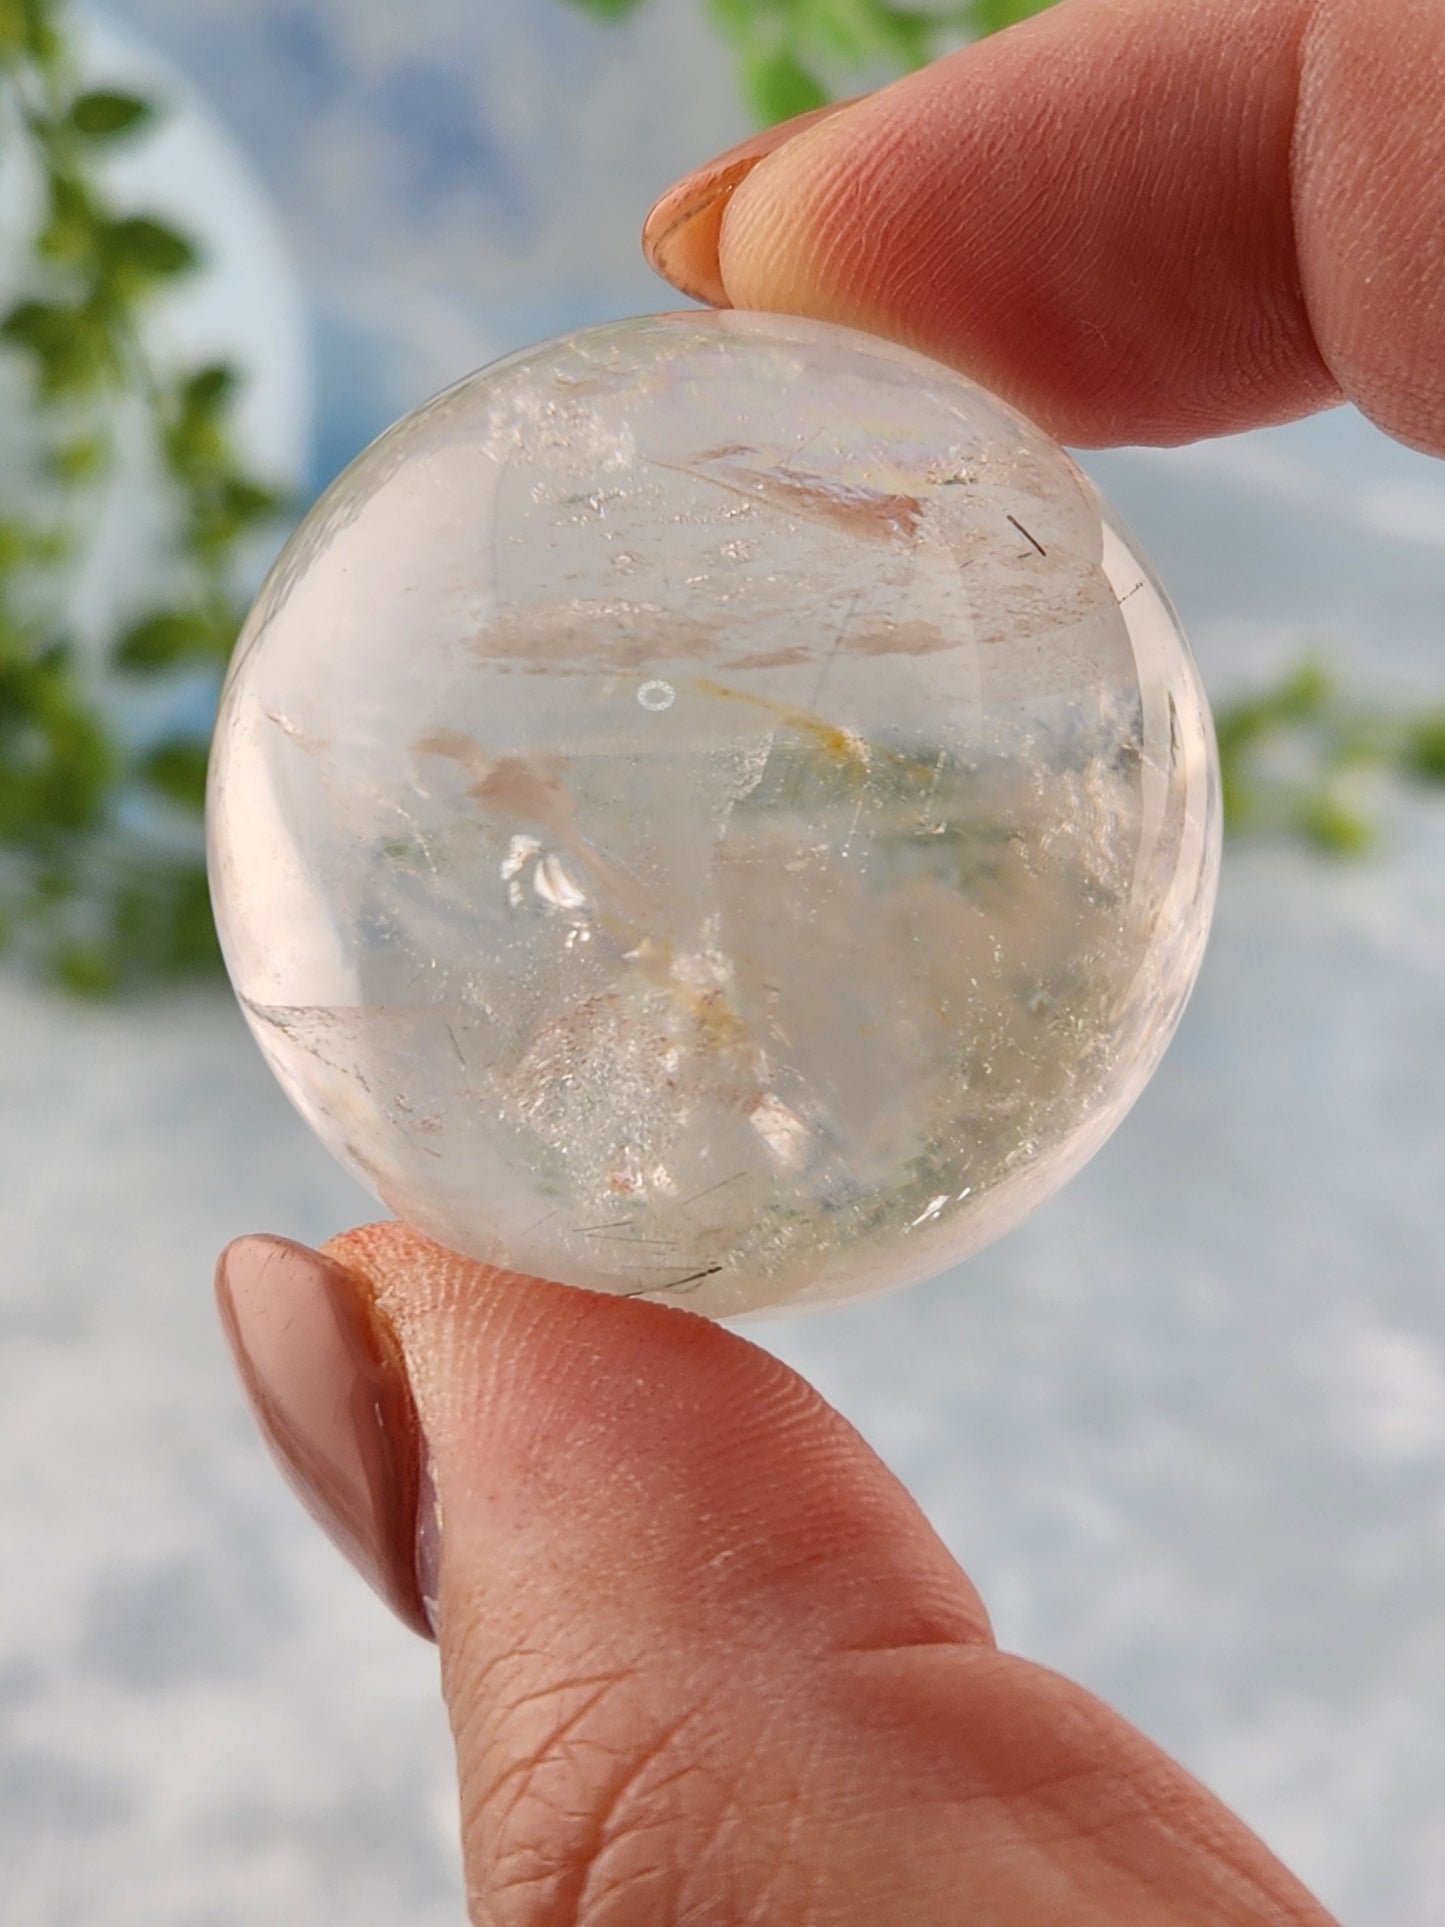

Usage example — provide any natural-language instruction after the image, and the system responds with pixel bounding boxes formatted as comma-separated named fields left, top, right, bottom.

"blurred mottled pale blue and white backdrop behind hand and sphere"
left=0, top=0, right=1445, bottom=1927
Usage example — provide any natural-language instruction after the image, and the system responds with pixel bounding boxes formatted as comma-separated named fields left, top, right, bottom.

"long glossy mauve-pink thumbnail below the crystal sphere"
left=216, top=1237, right=437, bottom=1638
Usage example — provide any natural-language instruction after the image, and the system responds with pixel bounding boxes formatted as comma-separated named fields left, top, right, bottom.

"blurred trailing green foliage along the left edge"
left=0, top=0, right=283, bottom=996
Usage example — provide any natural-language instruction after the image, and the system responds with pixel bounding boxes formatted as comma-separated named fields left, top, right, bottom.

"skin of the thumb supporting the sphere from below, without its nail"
left=329, top=1226, right=1348, bottom=1927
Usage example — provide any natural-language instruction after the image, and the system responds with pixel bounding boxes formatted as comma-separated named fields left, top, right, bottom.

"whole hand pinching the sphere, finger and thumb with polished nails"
left=222, top=0, right=1445, bottom=1927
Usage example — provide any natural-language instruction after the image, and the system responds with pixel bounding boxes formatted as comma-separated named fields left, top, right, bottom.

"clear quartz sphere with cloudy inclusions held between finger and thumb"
left=210, top=312, right=1220, bottom=1316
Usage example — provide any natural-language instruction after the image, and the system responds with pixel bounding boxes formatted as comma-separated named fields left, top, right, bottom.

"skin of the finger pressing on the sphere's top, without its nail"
left=709, top=0, right=1445, bottom=453
